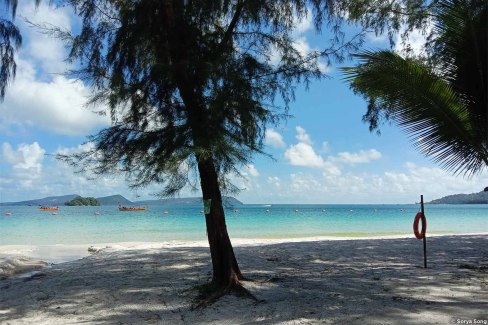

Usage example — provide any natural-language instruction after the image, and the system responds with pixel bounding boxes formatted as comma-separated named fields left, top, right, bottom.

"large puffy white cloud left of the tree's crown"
left=0, top=60, right=109, bottom=135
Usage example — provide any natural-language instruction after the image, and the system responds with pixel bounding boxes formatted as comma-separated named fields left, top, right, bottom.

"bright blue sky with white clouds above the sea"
left=0, top=1, right=488, bottom=203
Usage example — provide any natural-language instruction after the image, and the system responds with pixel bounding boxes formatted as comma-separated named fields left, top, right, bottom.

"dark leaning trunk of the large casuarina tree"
left=160, top=0, right=255, bottom=301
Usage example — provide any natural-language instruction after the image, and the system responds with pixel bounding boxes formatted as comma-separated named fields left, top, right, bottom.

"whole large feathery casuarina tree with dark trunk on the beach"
left=51, top=0, right=436, bottom=300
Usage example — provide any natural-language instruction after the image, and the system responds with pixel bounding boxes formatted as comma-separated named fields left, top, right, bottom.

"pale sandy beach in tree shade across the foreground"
left=0, top=235, right=488, bottom=324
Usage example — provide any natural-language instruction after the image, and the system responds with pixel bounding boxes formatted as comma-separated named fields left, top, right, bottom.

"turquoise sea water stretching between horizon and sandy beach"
left=0, top=204, right=488, bottom=245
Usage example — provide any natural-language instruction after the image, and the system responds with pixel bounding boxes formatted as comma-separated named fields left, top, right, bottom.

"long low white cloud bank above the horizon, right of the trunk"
left=239, top=163, right=488, bottom=204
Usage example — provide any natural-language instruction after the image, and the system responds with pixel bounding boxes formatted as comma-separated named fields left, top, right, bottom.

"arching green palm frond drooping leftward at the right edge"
left=343, top=51, right=488, bottom=173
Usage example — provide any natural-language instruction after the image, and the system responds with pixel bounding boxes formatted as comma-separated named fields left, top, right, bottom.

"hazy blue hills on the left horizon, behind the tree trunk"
left=0, top=194, right=244, bottom=208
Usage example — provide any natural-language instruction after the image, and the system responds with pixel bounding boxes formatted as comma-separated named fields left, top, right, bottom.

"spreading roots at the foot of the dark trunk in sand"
left=192, top=281, right=264, bottom=309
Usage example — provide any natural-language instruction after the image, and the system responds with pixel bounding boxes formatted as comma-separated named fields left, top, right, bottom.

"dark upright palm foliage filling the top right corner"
left=431, top=0, right=488, bottom=139
